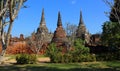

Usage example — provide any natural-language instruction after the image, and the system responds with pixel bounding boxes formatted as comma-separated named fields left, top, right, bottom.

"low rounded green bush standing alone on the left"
left=16, top=54, right=37, bottom=64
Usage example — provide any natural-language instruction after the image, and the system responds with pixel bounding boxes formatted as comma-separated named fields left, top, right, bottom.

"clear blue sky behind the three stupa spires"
left=12, top=0, right=109, bottom=36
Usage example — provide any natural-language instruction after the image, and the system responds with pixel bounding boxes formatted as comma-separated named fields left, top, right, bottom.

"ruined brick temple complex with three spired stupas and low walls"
left=0, top=9, right=107, bottom=54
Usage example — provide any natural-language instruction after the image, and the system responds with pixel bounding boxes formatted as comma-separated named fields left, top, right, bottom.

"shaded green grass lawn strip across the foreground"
left=0, top=61, right=120, bottom=71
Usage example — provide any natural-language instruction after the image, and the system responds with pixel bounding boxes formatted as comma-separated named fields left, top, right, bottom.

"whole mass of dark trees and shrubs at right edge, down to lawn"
left=101, top=0, right=120, bottom=60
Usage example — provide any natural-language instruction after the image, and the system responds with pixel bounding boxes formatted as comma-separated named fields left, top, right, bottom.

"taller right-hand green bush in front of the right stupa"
left=72, top=39, right=96, bottom=62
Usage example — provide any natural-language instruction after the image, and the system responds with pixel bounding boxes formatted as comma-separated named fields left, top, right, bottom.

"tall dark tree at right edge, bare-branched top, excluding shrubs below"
left=102, top=0, right=120, bottom=50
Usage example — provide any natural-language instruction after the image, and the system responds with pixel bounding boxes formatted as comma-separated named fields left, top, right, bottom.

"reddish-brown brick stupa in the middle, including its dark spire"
left=51, top=12, right=68, bottom=47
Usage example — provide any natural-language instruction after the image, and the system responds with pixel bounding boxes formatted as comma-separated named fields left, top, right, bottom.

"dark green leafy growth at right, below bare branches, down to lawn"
left=101, top=22, right=120, bottom=61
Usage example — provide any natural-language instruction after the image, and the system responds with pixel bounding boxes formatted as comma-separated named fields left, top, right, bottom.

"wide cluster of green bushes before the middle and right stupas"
left=46, top=40, right=96, bottom=63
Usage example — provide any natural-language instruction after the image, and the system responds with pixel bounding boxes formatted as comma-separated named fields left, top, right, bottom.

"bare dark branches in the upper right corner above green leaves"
left=103, top=0, right=120, bottom=24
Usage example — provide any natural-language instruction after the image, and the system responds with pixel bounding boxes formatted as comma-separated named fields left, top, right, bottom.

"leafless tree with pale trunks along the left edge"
left=0, top=0, right=26, bottom=62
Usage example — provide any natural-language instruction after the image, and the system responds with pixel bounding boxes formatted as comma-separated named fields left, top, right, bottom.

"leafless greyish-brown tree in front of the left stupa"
left=27, top=33, right=49, bottom=54
